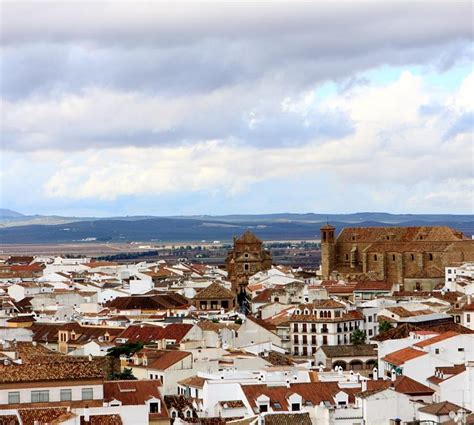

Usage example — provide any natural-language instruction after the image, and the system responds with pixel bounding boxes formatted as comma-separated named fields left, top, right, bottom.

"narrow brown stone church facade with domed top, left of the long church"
left=225, top=230, right=272, bottom=293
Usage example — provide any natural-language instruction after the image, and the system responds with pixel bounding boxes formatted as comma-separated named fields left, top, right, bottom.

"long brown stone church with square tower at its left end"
left=321, top=224, right=474, bottom=291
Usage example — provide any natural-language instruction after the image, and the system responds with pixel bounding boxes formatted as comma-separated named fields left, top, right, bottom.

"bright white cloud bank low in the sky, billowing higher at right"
left=29, top=73, right=473, bottom=214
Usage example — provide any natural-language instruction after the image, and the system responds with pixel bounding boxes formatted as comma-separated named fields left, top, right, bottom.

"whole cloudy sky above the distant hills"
left=0, top=0, right=474, bottom=216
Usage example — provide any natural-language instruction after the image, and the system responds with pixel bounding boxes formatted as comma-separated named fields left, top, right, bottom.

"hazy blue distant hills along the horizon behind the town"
left=0, top=209, right=474, bottom=244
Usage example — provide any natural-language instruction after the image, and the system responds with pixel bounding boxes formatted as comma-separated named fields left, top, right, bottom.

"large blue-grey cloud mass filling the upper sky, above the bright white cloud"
left=0, top=2, right=472, bottom=150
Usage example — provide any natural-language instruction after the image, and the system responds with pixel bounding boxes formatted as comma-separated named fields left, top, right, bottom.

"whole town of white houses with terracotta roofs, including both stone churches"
left=0, top=223, right=474, bottom=425
